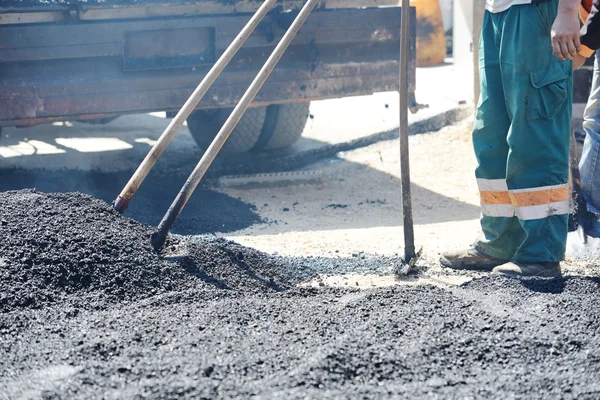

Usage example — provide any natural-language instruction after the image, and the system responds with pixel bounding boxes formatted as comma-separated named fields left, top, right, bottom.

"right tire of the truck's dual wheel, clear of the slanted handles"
left=252, top=102, right=310, bottom=151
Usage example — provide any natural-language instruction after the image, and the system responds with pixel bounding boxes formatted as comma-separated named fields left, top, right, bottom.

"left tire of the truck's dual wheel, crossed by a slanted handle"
left=187, top=107, right=267, bottom=154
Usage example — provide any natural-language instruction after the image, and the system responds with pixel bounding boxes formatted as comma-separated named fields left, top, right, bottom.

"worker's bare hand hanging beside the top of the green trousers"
left=551, top=8, right=581, bottom=60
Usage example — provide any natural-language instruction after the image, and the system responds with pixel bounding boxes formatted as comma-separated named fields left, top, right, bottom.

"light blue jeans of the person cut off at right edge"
left=579, top=51, right=600, bottom=237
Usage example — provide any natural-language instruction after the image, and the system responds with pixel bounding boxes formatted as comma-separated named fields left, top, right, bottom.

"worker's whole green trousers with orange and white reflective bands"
left=473, top=0, right=572, bottom=262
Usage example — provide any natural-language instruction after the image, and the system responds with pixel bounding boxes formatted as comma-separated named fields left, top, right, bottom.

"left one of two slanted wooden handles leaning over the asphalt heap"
left=113, top=0, right=277, bottom=213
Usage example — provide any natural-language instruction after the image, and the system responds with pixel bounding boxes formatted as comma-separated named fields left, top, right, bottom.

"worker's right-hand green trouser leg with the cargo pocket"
left=500, top=0, right=572, bottom=268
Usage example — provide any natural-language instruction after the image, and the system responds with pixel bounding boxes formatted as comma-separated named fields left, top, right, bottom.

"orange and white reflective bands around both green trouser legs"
left=477, top=179, right=569, bottom=220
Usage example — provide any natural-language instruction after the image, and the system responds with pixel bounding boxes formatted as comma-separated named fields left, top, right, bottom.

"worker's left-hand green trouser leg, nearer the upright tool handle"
left=473, top=12, right=523, bottom=260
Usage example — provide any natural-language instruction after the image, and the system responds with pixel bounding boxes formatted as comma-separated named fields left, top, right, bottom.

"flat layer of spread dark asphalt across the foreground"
left=0, top=277, right=600, bottom=399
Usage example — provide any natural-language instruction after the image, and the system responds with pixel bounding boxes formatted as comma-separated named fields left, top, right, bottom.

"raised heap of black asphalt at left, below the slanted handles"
left=0, top=190, right=287, bottom=312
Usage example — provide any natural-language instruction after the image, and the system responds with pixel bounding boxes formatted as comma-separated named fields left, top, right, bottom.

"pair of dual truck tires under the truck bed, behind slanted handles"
left=187, top=102, right=310, bottom=154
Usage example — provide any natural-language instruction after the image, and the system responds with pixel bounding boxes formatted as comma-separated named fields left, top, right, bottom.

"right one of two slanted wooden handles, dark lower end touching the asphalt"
left=152, top=0, right=319, bottom=251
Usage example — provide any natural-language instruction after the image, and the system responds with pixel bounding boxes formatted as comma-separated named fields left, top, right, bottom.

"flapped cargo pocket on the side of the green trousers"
left=527, top=62, right=571, bottom=120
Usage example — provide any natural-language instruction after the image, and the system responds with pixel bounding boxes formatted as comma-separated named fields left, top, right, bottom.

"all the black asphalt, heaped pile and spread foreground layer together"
left=0, top=191, right=600, bottom=399
